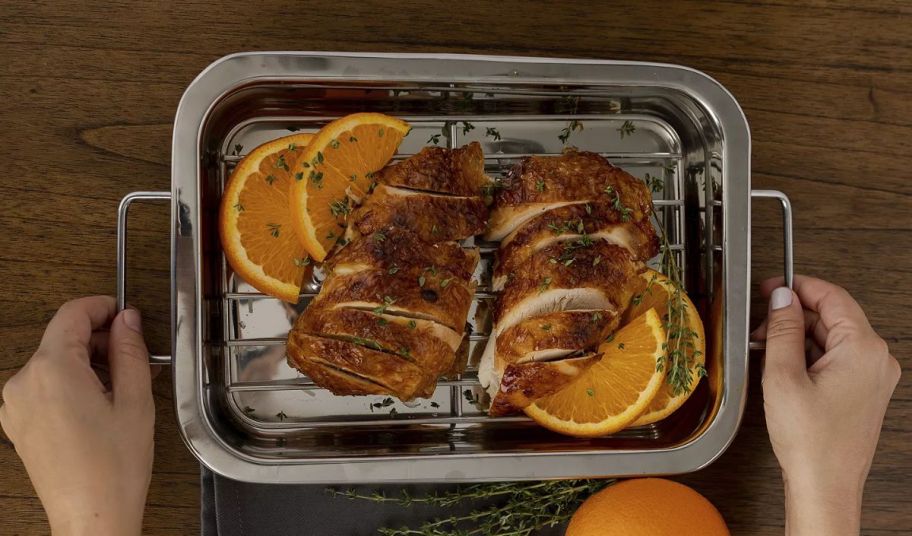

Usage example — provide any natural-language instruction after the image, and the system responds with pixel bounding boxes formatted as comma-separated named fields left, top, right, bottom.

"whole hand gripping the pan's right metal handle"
left=754, top=276, right=900, bottom=536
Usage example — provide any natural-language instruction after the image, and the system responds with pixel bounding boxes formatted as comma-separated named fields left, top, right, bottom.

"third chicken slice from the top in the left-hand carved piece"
left=324, top=223, right=479, bottom=280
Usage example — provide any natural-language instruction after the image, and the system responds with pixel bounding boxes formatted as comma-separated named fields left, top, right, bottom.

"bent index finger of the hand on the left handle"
left=41, top=296, right=116, bottom=355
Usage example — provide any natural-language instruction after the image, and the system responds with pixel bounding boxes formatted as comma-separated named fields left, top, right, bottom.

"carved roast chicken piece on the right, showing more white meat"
left=479, top=149, right=658, bottom=415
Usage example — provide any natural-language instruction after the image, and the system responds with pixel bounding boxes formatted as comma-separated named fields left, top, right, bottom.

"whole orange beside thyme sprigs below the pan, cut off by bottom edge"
left=565, top=478, right=730, bottom=536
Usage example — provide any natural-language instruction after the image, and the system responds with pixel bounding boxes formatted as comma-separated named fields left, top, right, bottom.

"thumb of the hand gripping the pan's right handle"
left=763, top=287, right=807, bottom=379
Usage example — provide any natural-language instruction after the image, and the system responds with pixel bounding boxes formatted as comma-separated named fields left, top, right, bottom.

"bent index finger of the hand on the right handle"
left=795, top=276, right=873, bottom=350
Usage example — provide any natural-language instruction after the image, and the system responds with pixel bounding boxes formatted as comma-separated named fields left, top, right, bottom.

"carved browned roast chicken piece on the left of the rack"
left=287, top=143, right=489, bottom=400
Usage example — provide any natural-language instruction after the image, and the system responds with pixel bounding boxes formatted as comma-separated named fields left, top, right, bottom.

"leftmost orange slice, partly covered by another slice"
left=219, top=134, right=313, bottom=303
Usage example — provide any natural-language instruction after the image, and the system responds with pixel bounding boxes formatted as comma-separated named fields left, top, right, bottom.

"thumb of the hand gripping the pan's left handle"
left=108, top=309, right=152, bottom=406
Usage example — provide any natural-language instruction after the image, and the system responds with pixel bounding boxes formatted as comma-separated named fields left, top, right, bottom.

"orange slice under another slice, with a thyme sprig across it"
left=621, top=270, right=706, bottom=426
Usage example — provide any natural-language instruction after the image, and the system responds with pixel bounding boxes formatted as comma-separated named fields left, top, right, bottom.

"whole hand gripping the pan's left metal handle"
left=0, top=296, right=155, bottom=536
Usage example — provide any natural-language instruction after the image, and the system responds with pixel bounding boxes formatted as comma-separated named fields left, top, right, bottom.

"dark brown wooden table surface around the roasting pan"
left=0, top=0, right=912, bottom=535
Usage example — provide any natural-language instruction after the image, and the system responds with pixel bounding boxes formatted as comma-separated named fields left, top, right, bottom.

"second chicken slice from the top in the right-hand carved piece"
left=492, top=203, right=659, bottom=292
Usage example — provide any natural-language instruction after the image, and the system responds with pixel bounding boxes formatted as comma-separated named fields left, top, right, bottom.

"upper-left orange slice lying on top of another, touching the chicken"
left=291, top=113, right=409, bottom=262
